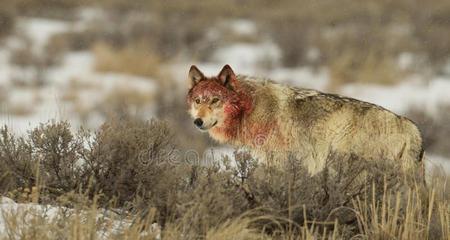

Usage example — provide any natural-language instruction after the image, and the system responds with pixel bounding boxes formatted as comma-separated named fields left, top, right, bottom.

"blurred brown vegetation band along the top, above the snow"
left=6, top=0, right=450, bottom=88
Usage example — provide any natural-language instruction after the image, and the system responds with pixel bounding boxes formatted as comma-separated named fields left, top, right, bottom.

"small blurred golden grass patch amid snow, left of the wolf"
left=93, top=43, right=161, bottom=77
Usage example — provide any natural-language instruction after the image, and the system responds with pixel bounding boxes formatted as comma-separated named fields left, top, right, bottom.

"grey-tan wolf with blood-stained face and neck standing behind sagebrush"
left=187, top=65, right=424, bottom=175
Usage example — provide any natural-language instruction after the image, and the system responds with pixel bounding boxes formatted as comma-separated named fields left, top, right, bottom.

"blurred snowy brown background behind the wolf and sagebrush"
left=0, top=0, right=450, bottom=169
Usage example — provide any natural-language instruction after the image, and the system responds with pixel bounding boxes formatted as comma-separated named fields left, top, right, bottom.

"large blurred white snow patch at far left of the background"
left=0, top=15, right=157, bottom=133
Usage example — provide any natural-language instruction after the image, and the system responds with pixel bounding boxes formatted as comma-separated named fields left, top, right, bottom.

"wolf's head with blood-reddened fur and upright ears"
left=187, top=65, right=249, bottom=134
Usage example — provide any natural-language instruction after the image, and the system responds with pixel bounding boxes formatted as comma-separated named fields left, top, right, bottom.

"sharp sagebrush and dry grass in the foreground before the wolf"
left=0, top=119, right=450, bottom=239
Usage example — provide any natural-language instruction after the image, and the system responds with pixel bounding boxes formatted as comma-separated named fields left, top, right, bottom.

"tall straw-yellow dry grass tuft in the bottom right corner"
left=352, top=179, right=450, bottom=239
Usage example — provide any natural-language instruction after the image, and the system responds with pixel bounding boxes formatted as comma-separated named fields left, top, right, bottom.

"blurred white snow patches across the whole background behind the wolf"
left=0, top=9, right=450, bottom=171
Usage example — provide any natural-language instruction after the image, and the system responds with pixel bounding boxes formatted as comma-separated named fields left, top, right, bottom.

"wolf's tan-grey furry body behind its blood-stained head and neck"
left=233, top=76, right=423, bottom=174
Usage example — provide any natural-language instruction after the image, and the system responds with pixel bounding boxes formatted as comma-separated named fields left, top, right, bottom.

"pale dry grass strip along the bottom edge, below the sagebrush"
left=3, top=172, right=450, bottom=240
